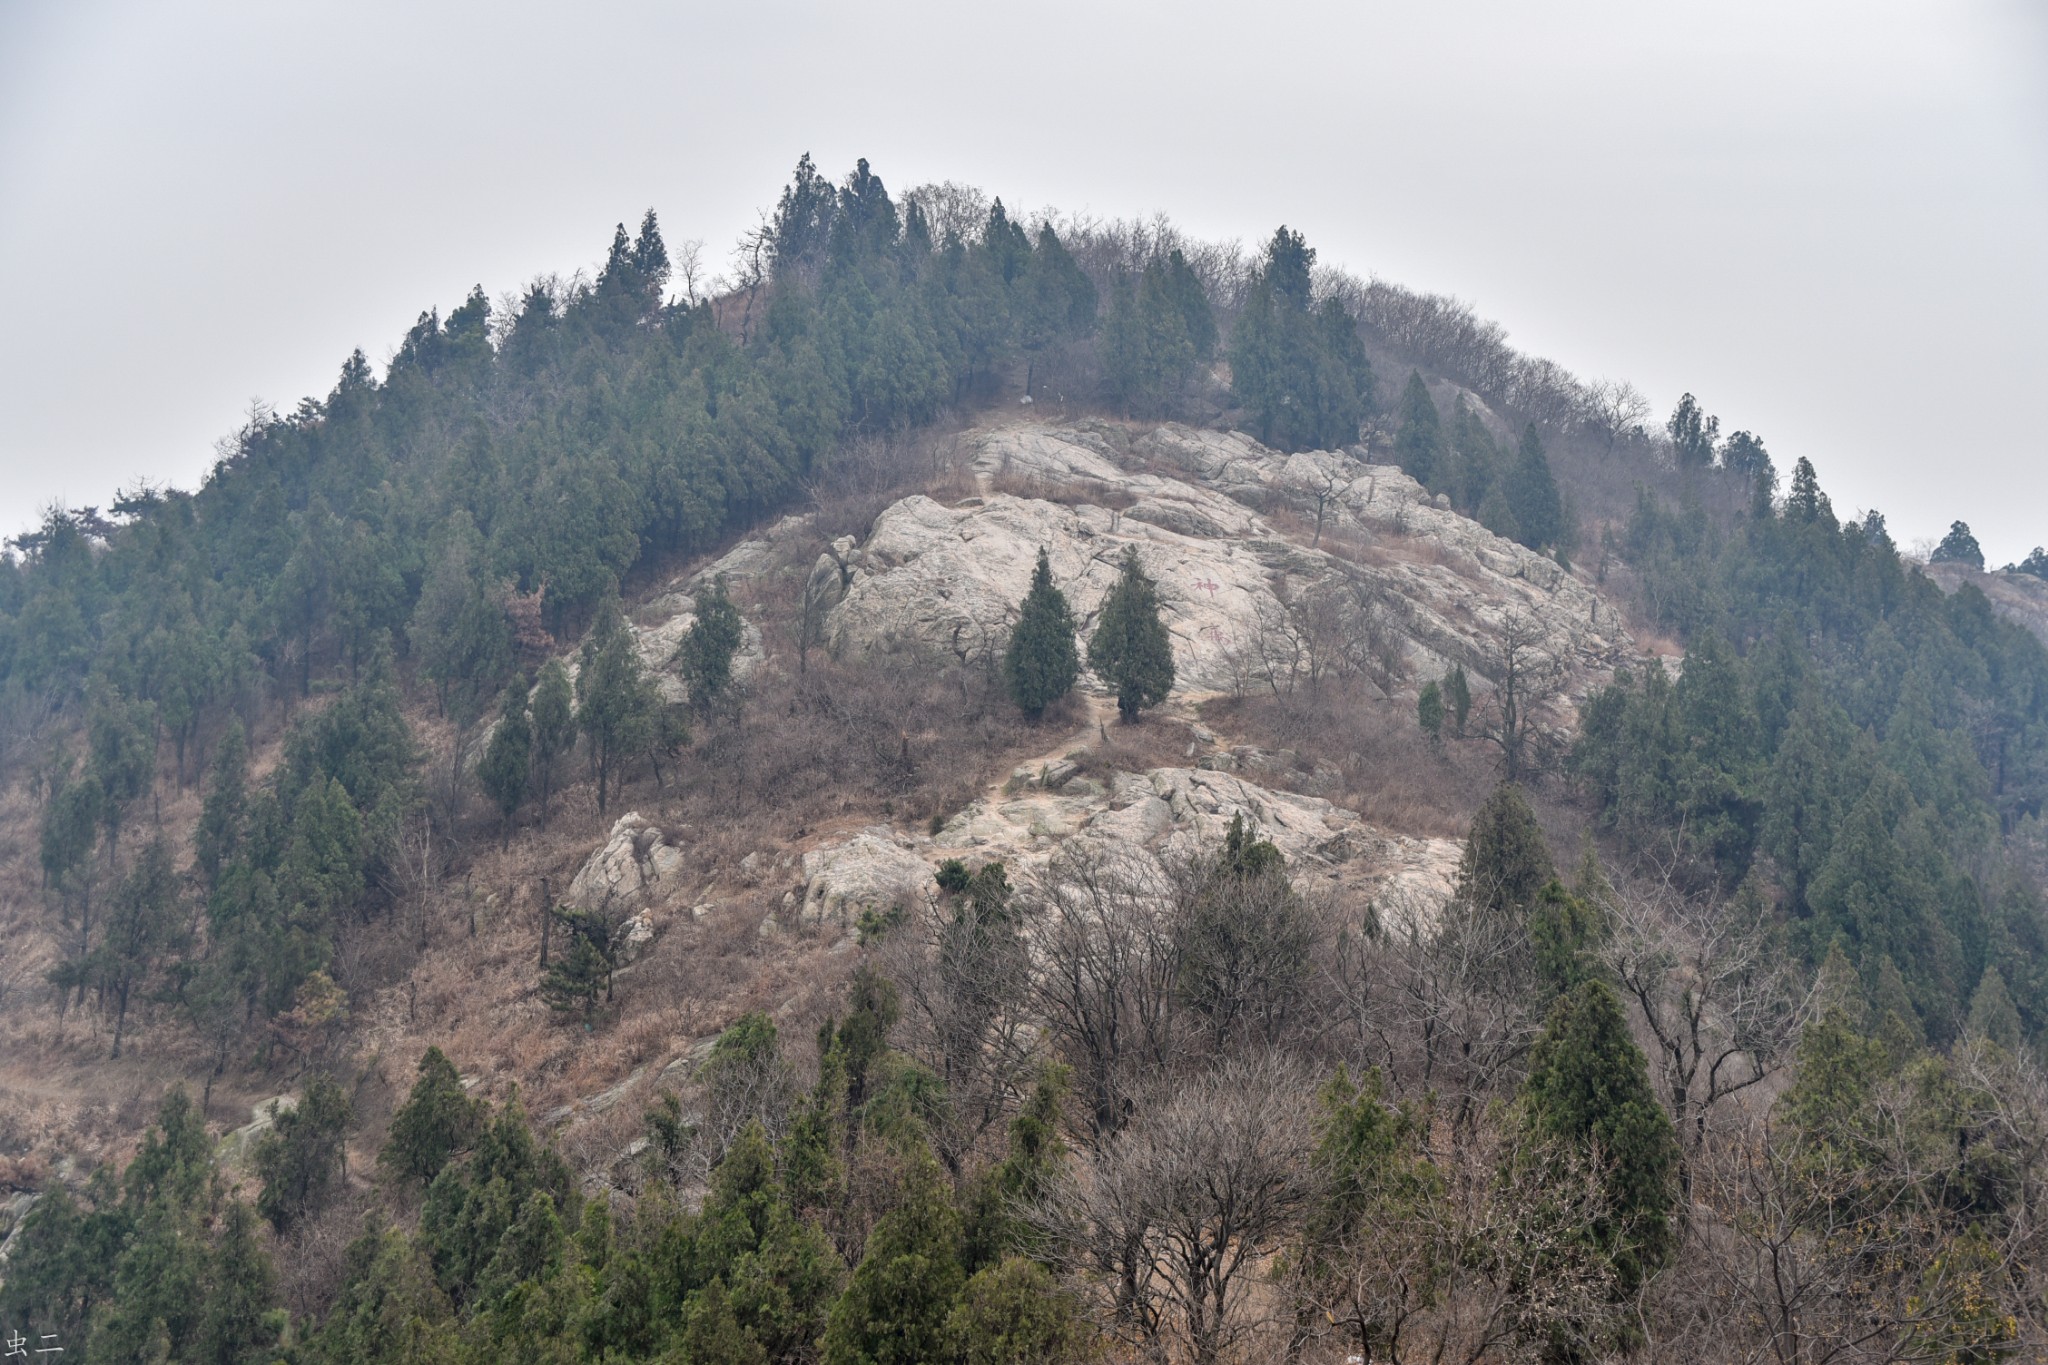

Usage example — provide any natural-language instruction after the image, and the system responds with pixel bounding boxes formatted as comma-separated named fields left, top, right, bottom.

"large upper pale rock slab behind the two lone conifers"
left=813, top=424, right=1632, bottom=696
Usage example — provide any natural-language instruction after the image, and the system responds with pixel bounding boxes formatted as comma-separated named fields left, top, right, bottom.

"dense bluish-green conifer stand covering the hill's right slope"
left=1575, top=458, right=2048, bottom=1042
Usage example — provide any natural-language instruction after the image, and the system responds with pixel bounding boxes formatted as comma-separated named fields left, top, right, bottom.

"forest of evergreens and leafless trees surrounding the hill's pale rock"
left=0, top=158, right=2048, bottom=1365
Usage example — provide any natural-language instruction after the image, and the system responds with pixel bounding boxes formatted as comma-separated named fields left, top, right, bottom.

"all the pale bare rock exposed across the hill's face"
left=575, top=420, right=1634, bottom=982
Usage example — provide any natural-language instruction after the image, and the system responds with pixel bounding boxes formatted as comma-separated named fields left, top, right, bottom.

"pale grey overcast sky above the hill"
left=0, top=0, right=2048, bottom=563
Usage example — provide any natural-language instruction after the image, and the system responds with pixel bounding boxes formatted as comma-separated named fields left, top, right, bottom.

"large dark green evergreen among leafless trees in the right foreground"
left=1522, top=978, right=1679, bottom=1295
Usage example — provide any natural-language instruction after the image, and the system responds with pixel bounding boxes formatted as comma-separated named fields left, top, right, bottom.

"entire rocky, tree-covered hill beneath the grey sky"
left=0, top=160, right=2048, bottom=1365
